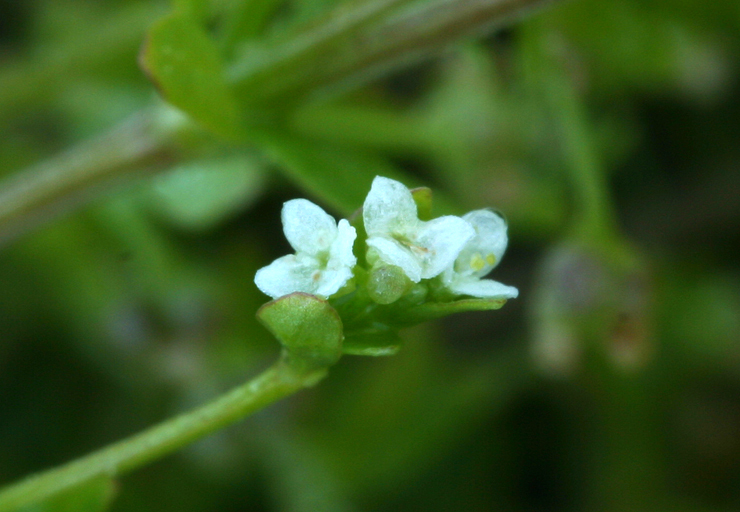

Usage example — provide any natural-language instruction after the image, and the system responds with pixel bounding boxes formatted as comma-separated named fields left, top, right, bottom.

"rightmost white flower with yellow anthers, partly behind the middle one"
left=442, top=210, right=519, bottom=299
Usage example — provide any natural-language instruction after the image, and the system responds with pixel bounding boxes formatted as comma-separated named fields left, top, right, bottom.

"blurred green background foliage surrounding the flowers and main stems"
left=0, top=0, right=740, bottom=512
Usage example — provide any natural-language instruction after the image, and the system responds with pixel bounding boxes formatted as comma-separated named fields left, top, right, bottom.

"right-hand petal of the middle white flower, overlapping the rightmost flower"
left=412, top=215, right=475, bottom=279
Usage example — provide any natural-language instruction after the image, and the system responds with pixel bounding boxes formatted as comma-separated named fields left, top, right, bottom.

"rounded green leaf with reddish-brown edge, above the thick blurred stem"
left=140, top=12, right=243, bottom=139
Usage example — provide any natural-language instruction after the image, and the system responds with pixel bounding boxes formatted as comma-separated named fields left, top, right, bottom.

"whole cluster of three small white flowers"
left=255, top=176, right=518, bottom=299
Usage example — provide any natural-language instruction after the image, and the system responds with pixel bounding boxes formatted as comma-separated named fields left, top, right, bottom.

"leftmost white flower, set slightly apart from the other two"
left=254, top=199, right=357, bottom=299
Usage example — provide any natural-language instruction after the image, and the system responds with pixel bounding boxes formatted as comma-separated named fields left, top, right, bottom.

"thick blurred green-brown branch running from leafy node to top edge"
left=230, top=0, right=554, bottom=103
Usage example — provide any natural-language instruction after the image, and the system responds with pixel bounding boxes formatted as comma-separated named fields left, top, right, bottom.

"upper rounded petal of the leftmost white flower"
left=281, top=199, right=337, bottom=256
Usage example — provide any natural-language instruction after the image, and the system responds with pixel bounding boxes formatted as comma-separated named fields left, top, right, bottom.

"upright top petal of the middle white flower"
left=362, top=176, right=419, bottom=237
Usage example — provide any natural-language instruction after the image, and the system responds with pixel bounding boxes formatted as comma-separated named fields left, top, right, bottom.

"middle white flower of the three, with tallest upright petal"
left=362, top=176, right=475, bottom=283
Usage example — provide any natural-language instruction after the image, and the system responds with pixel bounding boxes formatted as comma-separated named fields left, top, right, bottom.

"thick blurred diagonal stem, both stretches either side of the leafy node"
left=0, top=0, right=554, bottom=249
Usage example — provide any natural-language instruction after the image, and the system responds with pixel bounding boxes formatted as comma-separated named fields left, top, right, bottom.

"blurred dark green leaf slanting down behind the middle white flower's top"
left=249, top=130, right=409, bottom=215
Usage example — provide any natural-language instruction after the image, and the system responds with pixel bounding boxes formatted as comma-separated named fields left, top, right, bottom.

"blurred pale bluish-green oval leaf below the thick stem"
left=152, top=155, right=265, bottom=231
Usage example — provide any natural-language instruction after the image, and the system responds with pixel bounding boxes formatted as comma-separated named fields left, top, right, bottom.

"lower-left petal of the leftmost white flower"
left=254, top=254, right=318, bottom=299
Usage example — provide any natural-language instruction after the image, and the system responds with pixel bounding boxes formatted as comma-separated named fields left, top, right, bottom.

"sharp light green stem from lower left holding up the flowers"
left=0, top=358, right=326, bottom=512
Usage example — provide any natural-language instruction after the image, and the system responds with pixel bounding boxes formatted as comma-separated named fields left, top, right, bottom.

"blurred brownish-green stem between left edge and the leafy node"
left=0, top=110, right=175, bottom=245
